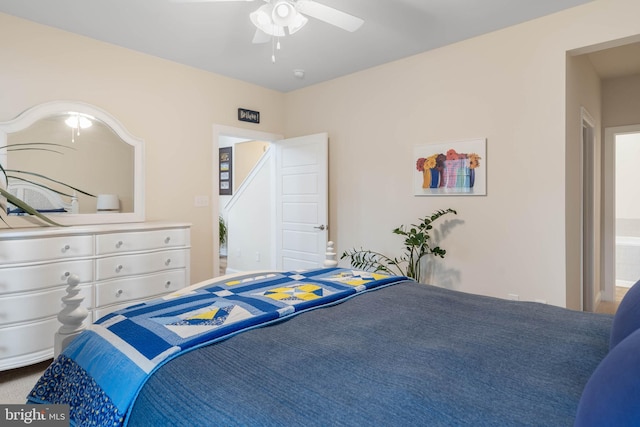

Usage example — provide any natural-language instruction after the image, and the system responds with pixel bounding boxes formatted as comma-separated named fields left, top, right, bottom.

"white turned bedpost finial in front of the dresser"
left=53, top=273, right=89, bottom=356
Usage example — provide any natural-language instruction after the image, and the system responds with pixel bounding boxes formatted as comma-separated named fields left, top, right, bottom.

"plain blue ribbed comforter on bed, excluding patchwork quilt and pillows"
left=129, top=281, right=612, bottom=427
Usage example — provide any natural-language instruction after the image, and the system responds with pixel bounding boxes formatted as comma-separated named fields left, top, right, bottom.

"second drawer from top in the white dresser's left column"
left=0, top=259, right=93, bottom=295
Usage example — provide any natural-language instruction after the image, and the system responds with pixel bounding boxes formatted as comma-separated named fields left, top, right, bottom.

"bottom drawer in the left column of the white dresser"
left=0, top=317, right=60, bottom=362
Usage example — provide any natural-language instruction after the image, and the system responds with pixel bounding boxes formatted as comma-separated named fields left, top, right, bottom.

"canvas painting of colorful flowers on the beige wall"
left=412, top=138, right=487, bottom=196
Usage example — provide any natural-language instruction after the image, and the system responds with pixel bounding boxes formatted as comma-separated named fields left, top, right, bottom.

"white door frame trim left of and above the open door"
left=211, top=124, right=283, bottom=277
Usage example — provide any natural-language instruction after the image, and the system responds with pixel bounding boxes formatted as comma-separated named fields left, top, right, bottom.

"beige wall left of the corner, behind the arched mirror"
left=0, top=14, right=284, bottom=282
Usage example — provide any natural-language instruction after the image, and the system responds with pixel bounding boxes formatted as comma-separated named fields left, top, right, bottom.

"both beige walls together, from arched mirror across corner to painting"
left=0, top=0, right=640, bottom=308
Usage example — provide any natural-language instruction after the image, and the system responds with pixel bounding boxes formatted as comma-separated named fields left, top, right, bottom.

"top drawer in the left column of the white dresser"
left=0, top=236, right=93, bottom=265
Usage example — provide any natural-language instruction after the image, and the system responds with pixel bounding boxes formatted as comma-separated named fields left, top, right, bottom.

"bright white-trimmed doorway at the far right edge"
left=603, top=124, right=640, bottom=310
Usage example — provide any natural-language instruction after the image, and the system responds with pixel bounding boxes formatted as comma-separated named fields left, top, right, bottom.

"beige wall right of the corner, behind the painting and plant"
left=285, top=0, right=640, bottom=308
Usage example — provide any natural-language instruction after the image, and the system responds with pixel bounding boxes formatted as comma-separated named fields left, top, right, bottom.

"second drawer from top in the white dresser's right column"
left=96, top=250, right=188, bottom=280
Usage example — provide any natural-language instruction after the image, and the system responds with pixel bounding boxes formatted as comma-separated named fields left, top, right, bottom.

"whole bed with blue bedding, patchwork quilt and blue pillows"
left=23, top=268, right=640, bottom=426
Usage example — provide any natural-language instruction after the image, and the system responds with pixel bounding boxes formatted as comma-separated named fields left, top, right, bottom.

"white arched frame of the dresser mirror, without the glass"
left=0, top=101, right=145, bottom=227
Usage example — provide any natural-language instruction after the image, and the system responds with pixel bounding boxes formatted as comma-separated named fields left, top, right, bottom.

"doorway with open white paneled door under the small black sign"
left=213, top=126, right=328, bottom=274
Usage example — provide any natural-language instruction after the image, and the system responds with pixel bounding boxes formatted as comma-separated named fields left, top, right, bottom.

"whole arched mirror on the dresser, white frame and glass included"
left=0, top=101, right=144, bottom=226
